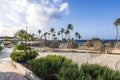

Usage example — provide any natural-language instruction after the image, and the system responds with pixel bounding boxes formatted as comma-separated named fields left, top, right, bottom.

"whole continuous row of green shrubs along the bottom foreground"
left=28, top=55, right=120, bottom=80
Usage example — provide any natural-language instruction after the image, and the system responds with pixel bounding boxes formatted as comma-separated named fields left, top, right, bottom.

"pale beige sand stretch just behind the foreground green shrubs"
left=37, top=52, right=120, bottom=70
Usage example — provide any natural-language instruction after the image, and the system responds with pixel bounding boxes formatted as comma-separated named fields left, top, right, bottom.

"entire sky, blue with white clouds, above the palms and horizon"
left=0, top=0, right=120, bottom=39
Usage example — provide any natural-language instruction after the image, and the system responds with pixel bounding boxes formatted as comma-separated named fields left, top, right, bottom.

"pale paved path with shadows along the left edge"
left=0, top=48, right=27, bottom=80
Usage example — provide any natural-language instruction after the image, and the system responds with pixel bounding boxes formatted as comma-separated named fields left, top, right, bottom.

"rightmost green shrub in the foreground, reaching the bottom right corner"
left=80, top=64, right=120, bottom=80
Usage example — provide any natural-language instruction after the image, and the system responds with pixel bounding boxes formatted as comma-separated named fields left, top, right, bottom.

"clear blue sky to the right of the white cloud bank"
left=51, top=0, right=120, bottom=39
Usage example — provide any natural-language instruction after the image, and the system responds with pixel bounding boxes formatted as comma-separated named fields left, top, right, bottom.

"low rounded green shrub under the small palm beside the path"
left=11, top=50, right=38, bottom=62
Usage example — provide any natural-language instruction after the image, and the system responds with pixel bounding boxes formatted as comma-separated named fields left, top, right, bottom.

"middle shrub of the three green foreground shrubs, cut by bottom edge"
left=59, top=63, right=80, bottom=80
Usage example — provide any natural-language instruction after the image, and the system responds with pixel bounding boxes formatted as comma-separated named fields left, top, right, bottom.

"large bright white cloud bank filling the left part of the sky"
left=0, top=0, right=69, bottom=36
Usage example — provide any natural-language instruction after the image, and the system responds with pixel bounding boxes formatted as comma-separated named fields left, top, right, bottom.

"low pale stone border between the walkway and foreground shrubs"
left=13, top=61, right=42, bottom=80
